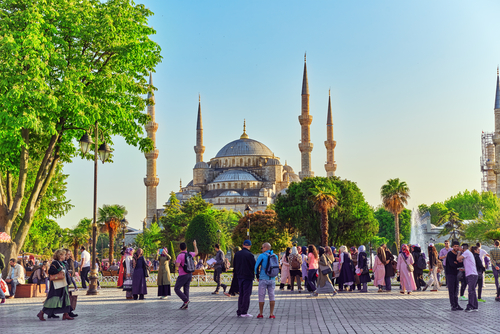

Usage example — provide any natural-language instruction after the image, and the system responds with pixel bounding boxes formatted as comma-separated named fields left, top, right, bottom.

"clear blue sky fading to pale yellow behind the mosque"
left=58, top=0, right=500, bottom=228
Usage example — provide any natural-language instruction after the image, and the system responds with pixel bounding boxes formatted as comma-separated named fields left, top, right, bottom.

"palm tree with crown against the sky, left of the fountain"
left=380, top=178, right=410, bottom=250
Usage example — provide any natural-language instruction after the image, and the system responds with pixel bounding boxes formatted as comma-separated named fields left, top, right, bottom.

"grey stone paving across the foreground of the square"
left=0, top=284, right=500, bottom=334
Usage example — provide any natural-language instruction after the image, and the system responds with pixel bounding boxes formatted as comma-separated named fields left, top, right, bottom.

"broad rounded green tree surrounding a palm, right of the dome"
left=274, top=177, right=378, bottom=246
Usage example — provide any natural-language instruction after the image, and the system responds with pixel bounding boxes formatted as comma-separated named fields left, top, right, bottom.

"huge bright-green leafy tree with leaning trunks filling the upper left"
left=0, top=0, right=161, bottom=274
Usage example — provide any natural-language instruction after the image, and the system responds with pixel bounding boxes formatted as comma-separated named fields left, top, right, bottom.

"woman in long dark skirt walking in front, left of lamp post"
left=37, top=249, right=74, bottom=321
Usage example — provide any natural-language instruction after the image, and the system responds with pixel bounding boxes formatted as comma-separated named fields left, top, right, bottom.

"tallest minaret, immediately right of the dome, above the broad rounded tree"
left=299, top=54, right=314, bottom=180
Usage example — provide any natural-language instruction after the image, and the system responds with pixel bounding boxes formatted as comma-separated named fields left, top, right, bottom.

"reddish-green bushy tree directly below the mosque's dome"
left=232, top=210, right=292, bottom=254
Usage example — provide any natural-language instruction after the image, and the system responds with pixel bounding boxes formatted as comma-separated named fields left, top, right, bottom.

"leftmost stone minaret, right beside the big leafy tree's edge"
left=144, top=73, right=160, bottom=228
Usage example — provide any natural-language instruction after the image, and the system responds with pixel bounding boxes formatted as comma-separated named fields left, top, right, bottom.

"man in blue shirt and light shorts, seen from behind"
left=255, top=242, right=276, bottom=319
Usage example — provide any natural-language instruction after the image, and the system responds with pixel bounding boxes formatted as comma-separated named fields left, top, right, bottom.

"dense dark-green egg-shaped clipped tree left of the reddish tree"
left=186, top=212, right=225, bottom=262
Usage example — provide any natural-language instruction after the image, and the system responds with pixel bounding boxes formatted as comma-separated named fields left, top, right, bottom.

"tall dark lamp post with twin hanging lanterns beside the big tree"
left=80, top=121, right=111, bottom=295
